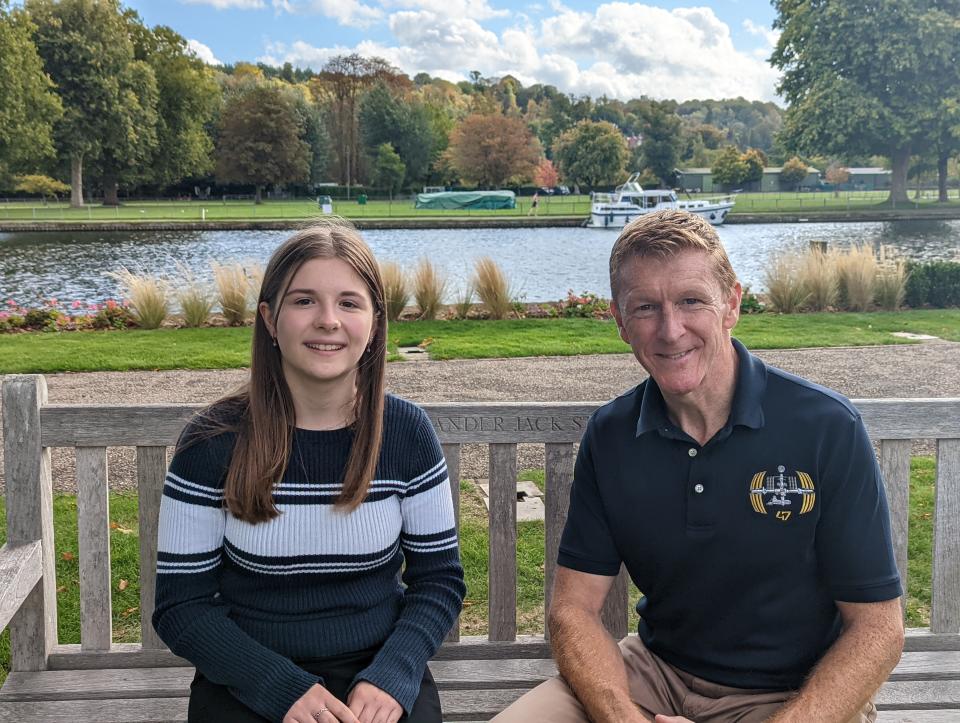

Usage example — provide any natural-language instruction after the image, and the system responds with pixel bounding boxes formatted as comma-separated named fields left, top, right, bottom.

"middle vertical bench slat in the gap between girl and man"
left=488, top=444, right=517, bottom=640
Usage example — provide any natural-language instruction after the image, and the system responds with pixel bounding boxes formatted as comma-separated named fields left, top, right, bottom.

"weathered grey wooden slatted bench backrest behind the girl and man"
left=3, top=376, right=960, bottom=670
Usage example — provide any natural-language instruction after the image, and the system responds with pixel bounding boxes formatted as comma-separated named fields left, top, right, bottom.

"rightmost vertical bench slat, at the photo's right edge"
left=930, top=436, right=960, bottom=633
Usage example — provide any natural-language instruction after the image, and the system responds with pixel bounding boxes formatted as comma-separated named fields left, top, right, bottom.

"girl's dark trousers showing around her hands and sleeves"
left=187, top=649, right=443, bottom=723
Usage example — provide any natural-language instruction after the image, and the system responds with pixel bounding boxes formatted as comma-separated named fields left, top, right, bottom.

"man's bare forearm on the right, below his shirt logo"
left=768, top=600, right=903, bottom=723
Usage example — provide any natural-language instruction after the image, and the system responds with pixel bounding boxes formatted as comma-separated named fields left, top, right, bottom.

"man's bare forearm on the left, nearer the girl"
left=549, top=606, right=648, bottom=723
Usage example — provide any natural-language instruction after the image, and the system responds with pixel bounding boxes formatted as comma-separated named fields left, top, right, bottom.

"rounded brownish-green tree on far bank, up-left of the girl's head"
left=216, top=85, right=310, bottom=203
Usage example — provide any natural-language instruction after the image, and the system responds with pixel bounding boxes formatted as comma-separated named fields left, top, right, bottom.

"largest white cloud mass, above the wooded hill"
left=251, top=0, right=777, bottom=101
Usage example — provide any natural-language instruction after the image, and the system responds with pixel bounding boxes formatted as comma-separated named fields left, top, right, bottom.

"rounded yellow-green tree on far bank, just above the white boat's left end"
left=553, top=120, right=627, bottom=186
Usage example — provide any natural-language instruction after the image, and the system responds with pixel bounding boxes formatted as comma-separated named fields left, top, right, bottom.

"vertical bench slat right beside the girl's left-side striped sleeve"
left=137, top=447, right=167, bottom=649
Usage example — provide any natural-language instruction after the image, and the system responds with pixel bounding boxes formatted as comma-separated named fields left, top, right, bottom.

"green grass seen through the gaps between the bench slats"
left=0, top=457, right=935, bottom=684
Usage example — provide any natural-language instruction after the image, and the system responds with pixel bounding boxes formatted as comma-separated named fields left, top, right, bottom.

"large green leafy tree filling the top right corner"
left=771, top=0, right=960, bottom=203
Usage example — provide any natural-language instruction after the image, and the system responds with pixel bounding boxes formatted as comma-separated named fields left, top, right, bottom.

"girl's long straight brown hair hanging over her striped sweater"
left=210, top=219, right=387, bottom=523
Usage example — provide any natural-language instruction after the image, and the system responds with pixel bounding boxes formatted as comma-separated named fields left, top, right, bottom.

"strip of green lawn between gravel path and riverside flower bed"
left=0, top=309, right=960, bottom=374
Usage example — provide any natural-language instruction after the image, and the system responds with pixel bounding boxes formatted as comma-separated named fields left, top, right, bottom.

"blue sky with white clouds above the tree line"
left=124, top=0, right=778, bottom=101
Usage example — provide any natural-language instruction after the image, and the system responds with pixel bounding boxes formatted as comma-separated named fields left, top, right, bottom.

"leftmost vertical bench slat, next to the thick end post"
left=77, top=447, right=112, bottom=650
